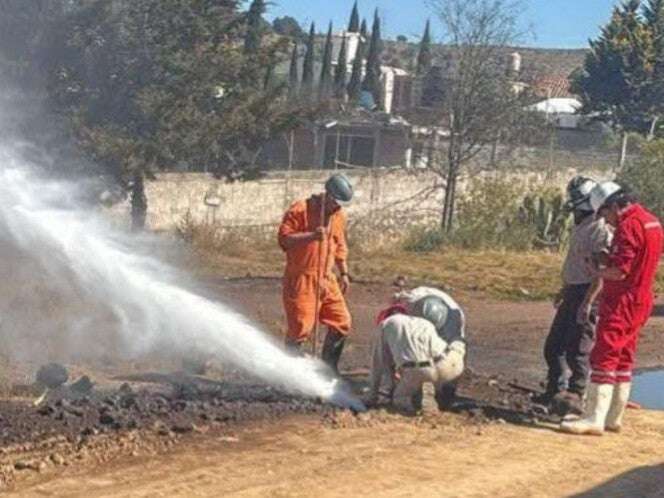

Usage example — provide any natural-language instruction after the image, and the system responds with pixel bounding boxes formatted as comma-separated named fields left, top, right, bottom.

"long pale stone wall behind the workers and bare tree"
left=110, top=169, right=606, bottom=243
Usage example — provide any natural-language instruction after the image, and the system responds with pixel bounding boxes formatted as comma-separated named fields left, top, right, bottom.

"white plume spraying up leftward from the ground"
left=0, top=149, right=362, bottom=409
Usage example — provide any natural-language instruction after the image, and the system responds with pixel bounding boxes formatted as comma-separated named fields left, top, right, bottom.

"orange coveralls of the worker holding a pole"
left=279, top=196, right=351, bottom=343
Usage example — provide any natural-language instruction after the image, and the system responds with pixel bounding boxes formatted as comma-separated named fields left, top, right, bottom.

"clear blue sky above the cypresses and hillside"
left=267, top=0, right=618, bottom=48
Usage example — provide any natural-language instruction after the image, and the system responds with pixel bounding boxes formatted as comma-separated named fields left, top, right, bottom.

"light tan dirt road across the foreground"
left=8, top=412, right=664, bottom=498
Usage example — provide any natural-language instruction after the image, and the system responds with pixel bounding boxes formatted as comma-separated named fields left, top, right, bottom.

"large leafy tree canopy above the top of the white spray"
left=52, top=0, right=302, bottom=185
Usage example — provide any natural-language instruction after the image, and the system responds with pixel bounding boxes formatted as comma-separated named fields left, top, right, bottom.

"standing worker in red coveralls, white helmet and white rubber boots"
left=561, top=182, right=664, bottom=435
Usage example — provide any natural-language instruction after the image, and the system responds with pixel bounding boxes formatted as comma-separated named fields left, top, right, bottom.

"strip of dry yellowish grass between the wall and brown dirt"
left=183, top=227, right=562, bottom=301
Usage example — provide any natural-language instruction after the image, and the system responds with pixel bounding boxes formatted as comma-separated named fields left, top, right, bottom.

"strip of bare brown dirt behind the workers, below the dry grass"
left=218, top=279, right=664, bottom=383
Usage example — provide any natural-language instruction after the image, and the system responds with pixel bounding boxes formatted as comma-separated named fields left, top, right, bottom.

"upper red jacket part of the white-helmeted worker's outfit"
left=604, top=204, right=664, bottom=301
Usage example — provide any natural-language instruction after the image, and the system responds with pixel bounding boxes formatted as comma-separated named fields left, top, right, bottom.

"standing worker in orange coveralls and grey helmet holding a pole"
left=279, top=174, right=353, bottom=372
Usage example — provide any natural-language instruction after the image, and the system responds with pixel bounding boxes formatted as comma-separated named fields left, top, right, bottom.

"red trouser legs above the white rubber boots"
left=590, top=293, right=653, bottom=384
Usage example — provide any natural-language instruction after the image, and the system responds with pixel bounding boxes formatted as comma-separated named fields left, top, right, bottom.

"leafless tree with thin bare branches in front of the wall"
left=423, top=0, right=528, bottom=232
